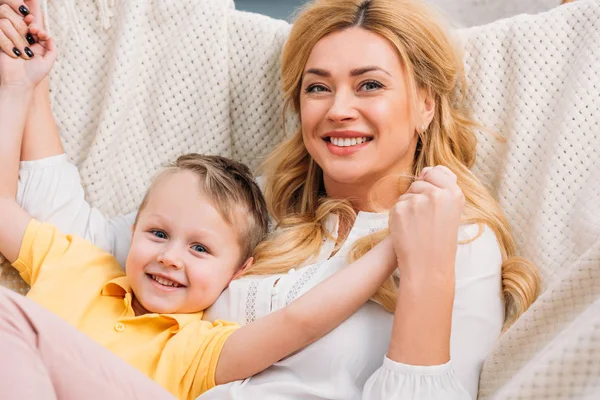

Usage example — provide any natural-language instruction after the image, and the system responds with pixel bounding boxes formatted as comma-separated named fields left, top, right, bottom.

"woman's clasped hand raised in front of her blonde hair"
left=390, top=166, right=464, bottom=286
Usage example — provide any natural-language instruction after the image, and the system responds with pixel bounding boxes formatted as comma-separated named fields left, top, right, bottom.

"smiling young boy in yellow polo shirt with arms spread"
left=0, top=10, right=395, bottom=399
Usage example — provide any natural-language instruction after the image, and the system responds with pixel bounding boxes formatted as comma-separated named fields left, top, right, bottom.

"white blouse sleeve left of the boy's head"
left=17, top=154, right=135, bottom=267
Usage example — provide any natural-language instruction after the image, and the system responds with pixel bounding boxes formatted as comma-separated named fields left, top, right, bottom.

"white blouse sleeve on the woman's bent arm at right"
left=363, top=225, right=504, bottom=400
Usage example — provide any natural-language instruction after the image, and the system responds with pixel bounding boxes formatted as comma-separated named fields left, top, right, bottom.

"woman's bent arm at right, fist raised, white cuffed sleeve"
left=364, top=167, right=503, bottom=399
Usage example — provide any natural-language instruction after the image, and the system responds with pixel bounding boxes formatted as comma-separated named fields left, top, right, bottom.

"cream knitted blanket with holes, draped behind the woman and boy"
left=0, top=0, right=600, bottom=399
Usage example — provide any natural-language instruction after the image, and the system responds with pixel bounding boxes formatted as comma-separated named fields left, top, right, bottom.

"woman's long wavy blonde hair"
left=247, top=0, right=539, bottom=327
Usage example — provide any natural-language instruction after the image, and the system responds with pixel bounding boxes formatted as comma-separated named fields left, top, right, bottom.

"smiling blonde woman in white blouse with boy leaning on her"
left=4, top=0, right=537, bottom=399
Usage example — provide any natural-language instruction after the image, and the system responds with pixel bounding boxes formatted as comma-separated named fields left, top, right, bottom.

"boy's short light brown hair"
left=135, top=153, right=268, bottom=263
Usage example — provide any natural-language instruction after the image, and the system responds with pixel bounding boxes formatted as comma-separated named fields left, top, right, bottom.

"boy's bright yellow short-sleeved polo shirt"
left=13, top=220, right=238, bottom=399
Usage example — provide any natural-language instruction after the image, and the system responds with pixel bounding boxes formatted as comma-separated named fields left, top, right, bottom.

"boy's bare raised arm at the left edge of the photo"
left=0, top=86, right=33, bottom=263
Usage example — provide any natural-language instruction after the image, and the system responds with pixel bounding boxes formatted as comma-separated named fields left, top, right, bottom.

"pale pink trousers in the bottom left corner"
left=0, top=287, right=174, bottom=400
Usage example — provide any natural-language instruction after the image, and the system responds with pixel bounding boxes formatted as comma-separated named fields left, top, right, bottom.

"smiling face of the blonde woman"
left=300, top=28, right=428, bottom=196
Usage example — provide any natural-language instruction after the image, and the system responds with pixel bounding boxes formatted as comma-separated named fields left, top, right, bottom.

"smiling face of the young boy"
left=126, top=171, right=248, bottom=314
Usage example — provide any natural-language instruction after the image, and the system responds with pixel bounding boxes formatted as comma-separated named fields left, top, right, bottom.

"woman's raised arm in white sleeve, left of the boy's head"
left=17, top=79, right=135, bottom=266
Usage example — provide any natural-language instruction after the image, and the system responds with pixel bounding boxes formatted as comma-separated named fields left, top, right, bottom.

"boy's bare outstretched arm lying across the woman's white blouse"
left=215, top=238, right=396, bottom=385
